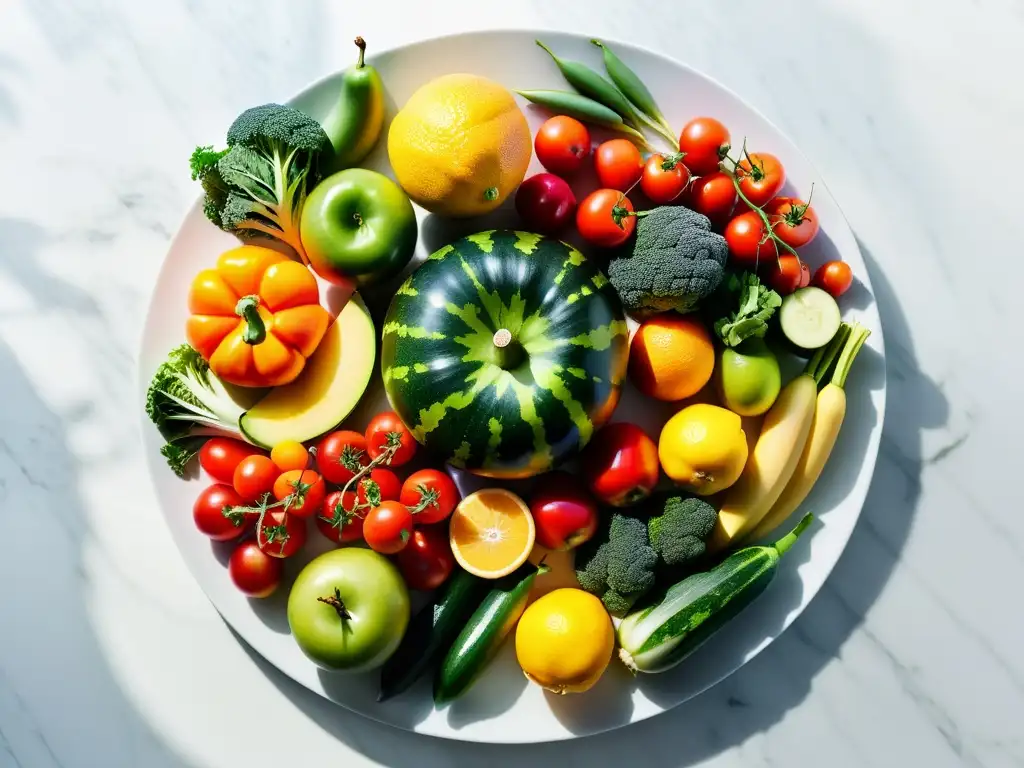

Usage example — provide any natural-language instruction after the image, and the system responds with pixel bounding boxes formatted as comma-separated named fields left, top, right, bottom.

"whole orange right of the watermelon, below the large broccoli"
left=630, top=313, right=715, bottom=400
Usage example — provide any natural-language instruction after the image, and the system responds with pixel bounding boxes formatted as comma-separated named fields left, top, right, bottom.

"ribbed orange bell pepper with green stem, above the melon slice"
left=185, top=246, right=331, bottom=387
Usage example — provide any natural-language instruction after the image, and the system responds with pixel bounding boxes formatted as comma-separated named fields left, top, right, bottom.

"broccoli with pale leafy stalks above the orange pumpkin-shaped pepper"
left=189, top=104, right=331, bottom=260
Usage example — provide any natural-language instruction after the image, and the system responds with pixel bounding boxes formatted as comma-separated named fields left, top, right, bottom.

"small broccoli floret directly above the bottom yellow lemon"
left=575, top=512, right=657, bottom=615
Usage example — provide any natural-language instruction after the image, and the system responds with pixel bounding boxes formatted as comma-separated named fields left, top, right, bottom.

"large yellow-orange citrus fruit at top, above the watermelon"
left=387, top=75, right=532, bottom=216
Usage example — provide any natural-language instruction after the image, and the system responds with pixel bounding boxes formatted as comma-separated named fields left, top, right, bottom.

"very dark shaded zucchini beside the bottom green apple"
left=377, top=568, right=489, bottom=701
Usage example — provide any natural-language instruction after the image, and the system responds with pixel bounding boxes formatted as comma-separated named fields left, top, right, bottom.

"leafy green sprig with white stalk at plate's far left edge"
left=145, top=344, right=245, bottom=477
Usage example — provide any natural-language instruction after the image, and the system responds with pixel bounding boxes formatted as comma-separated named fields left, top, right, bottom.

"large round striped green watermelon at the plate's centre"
left=381, top=230, right=629, bottom=478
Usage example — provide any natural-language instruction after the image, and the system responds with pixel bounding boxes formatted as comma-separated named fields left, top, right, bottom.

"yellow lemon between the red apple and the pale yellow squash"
left=657, top=403, right=748, bottom=496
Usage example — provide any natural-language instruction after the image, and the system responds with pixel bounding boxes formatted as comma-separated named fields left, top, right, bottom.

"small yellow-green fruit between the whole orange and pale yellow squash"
left=715, top=337, right=782, bottom=416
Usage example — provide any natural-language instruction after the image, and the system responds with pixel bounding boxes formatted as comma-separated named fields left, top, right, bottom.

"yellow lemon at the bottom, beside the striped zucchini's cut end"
left=515, top=588, right=615, bottom=693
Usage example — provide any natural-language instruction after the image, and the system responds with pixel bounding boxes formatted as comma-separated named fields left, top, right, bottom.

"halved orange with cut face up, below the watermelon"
left=449, top=488, right=535, bottom=579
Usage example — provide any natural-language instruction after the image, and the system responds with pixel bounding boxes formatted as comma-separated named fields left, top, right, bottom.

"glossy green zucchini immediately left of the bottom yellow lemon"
left=434, top=562, right=548, bottom=705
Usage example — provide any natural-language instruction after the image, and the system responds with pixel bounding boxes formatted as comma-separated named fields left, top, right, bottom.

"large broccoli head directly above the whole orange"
left=608, top=206, right=729, bottom=314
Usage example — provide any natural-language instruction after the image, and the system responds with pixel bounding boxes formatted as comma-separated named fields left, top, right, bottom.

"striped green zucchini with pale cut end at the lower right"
left=617, top=514, right=814, bottom=672
